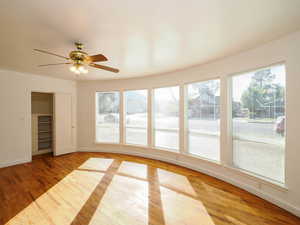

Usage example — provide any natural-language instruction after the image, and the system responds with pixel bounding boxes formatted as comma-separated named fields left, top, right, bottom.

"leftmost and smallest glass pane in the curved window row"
left=96, top=92, right=120, bottom=143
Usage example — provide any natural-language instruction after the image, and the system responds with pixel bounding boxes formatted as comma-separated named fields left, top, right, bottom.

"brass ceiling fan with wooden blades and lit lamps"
left=34, top=42, right=119, bottom=74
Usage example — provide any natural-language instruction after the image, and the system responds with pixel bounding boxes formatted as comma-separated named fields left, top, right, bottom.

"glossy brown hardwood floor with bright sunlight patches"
left=0, top=153, right=300, bottom=225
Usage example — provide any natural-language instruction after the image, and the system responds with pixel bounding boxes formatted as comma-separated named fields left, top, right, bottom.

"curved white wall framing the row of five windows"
left=77, top=32, right=300, bottom=216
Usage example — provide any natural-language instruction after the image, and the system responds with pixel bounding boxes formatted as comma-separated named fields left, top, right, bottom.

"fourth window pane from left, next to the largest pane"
left=187, top=80, right=220, bottom=161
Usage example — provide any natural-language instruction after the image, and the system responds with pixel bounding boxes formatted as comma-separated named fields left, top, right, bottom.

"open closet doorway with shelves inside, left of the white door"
left=31, top=92, right=53, bottom=156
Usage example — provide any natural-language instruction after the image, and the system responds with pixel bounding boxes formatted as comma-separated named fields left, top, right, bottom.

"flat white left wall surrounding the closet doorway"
left=0, top=70, right=76, bottom=167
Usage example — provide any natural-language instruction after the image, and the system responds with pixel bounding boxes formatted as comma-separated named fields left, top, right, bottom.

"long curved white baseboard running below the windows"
left=78, top=147, right=300, bottom=217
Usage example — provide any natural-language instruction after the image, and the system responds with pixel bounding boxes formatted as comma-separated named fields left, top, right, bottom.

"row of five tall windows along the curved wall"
left=96, top=62, right=286, bottom=183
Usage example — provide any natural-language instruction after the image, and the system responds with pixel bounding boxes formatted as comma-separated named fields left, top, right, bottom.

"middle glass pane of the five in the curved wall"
left=154, top=87, right=179, bottom=152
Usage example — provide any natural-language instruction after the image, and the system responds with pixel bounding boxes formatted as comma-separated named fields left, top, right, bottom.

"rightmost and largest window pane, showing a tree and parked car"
left=232, top=65, right=286, bottom=183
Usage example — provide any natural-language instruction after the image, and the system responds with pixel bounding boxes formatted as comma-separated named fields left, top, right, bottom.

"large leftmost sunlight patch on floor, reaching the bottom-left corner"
left=6, top=170, right=103, bottom=225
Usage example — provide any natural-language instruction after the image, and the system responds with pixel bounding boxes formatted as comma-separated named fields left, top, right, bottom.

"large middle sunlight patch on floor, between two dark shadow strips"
left=89, top=175, right=148, bottom=225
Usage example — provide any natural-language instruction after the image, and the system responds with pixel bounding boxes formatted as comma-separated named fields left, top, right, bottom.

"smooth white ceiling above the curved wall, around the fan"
left=0, top=0, right=300, bottom=79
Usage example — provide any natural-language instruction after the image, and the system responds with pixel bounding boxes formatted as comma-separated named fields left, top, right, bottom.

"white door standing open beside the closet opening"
left=54, top=93, right=75, bottom=155
